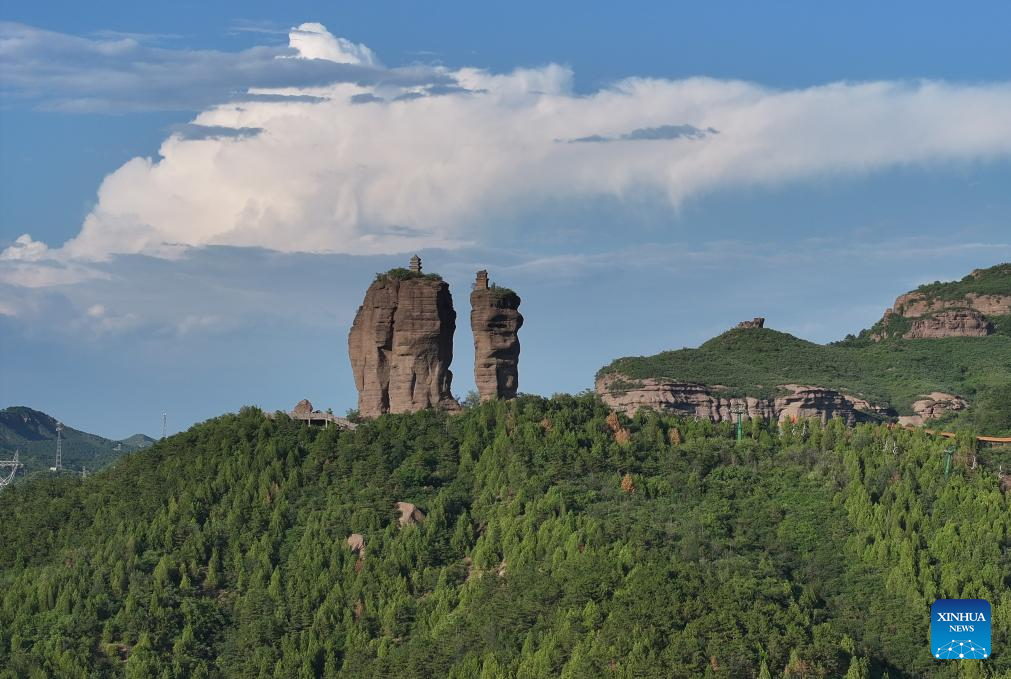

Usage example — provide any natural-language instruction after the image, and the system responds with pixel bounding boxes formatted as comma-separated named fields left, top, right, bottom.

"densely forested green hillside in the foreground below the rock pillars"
left=0, top=395, right=1011, bottom=679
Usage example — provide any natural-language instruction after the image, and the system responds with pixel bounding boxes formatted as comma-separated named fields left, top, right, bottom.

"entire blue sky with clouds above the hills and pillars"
left=0, top=2, right=1011, bottom=437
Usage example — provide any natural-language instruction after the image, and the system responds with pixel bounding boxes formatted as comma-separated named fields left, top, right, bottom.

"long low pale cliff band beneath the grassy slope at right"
left=595, top=373, right=885, bottom=424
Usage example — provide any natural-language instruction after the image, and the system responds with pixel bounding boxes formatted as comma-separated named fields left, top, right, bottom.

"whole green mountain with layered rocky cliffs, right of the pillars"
left=595, top=264, right=1011, bottom=434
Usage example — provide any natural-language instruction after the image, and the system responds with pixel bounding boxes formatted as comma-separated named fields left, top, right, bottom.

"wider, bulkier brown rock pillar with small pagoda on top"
left=348, top=261, right=460, bottom=417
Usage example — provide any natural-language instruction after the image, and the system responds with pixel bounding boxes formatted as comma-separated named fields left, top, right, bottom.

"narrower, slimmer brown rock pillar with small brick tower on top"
left=470, top=271, right=523, bottom=401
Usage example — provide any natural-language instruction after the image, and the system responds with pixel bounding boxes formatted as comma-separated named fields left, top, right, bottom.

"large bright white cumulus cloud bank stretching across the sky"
left=0, top=23, right=1011, bottom=261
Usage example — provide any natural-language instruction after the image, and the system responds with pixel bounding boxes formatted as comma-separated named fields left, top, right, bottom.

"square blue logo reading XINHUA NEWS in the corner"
left=930, top=599, right=993, bottom=660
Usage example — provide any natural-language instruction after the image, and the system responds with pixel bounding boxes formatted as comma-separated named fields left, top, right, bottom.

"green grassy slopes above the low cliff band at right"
left=601, top=265, right=1011, bottom=414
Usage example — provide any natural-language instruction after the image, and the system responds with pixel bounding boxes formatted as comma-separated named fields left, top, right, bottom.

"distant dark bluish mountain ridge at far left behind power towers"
left=0, top=405, right=154, bottom=475
